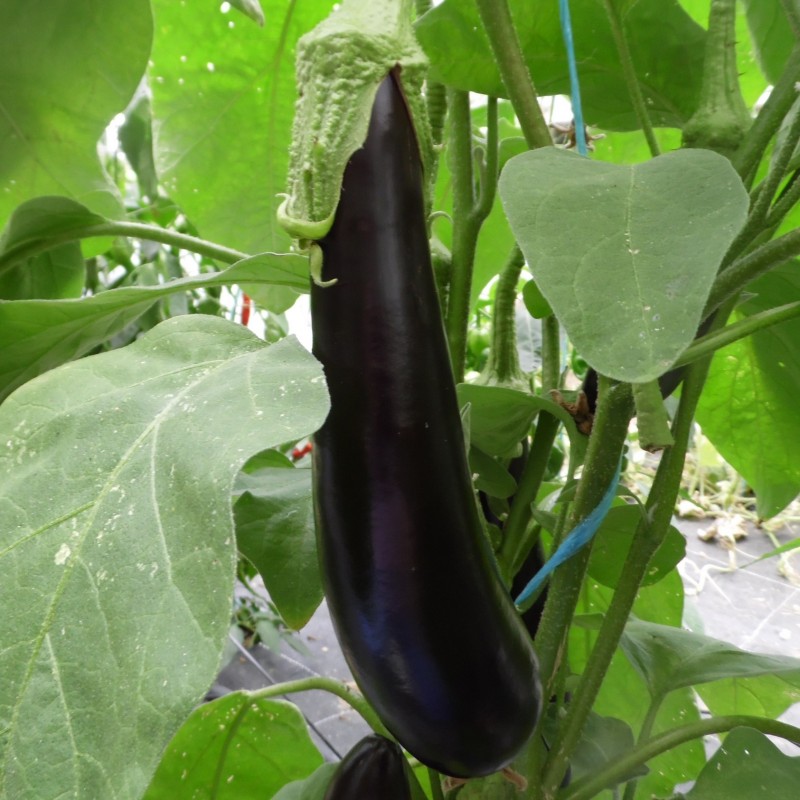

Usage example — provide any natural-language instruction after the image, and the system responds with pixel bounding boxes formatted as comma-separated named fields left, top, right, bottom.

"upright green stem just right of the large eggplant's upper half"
left=446, top=91, right=480, bottom=383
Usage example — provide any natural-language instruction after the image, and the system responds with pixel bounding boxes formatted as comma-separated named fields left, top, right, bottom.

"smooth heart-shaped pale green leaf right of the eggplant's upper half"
left=499, top=149, right=749, bottom=383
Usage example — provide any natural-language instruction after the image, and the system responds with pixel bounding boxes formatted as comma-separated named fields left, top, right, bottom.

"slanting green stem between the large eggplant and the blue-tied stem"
left=497, top=412, right=558, bottom=580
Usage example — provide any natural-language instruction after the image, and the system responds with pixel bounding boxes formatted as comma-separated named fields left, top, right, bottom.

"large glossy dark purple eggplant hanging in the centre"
left=311, top=75, right=541, bottom=777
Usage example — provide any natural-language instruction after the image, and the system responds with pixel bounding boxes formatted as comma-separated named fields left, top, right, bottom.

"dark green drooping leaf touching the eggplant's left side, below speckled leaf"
left=233, top=467, right=323, bottom=628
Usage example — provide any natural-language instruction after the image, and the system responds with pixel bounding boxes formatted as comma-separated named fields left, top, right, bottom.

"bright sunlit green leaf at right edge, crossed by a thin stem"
left=697, top=261, right=800, bottom=519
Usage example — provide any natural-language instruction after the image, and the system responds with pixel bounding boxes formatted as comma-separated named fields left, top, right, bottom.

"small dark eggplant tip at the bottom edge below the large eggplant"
left=323, top=734, right=411, bottom=800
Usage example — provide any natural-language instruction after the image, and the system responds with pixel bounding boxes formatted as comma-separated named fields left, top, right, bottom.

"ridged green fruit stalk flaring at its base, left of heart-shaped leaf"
left=477, top=245, right=528, bottom=390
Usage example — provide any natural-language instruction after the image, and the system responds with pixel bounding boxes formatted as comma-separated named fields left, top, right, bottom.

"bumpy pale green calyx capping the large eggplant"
left=278, top=0, right=432, bottom=242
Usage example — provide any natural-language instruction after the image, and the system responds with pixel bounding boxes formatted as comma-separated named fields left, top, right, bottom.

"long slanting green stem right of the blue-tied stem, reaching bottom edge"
left=542, top=308, right=730, bottom=798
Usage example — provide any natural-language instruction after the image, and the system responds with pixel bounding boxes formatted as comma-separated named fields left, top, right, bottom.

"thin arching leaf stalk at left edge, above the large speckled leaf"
left=0, top=220, right=249, bottom=275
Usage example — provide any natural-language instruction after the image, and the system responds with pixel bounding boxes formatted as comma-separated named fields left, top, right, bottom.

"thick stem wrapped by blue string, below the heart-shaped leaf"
left=536, top=379, right=633, bottom=700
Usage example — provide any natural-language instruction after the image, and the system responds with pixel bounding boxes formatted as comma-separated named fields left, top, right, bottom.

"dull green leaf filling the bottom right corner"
left=686, top=728, right=800, bottom=800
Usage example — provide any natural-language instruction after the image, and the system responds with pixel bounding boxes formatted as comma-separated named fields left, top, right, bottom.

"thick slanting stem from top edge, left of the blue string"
left=477, top=0, right=553, bottom=150
